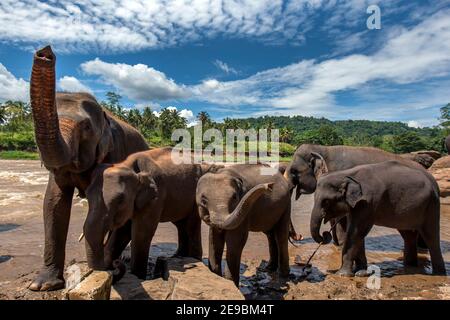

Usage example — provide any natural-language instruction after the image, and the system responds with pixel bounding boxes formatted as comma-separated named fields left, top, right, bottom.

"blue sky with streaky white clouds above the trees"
left=0, top=0, right=450, bottom=126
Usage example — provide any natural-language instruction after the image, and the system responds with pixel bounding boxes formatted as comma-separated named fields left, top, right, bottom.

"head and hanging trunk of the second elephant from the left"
left=83, top=164, right=157, bottom=270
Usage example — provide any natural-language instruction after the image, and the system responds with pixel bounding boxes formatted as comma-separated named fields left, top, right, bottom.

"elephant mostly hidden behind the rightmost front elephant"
left=285, top=144, right=424, bottom=245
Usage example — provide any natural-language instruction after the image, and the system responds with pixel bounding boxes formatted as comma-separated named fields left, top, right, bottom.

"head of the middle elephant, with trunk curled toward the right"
left=196, top=173, right=273, bottom=230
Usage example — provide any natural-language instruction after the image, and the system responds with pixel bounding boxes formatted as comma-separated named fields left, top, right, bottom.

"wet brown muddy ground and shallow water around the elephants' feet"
left=0, top=160, right=450, bottom=299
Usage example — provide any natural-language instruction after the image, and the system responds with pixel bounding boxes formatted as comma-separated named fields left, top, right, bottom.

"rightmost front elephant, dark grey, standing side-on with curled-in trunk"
left=310, top=161, right=446, bottom=276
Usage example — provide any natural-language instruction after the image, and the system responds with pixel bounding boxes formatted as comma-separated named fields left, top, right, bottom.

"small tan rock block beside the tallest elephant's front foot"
left=66, top=271, right=112, bottom=300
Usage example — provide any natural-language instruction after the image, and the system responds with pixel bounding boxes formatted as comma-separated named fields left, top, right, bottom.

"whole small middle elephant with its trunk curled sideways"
left=196, top=164, right=291, bottom=286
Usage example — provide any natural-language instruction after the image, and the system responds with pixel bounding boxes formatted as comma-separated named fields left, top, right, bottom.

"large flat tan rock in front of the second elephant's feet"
left=111, top=258, right=244, bottom=300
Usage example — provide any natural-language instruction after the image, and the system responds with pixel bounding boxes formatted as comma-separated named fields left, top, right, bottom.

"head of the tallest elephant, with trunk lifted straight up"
left=30, top=46, right=112, bottom=172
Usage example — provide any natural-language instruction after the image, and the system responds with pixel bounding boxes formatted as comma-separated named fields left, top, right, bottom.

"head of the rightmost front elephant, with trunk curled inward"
left=310, top=174, right=364, bottom=243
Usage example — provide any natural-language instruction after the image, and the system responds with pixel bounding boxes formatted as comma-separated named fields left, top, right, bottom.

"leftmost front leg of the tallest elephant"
left=29, top=173, right=74, bottom=291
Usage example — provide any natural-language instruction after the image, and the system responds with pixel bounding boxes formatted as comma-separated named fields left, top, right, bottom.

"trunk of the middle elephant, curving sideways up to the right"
left=214, top=183, right=273, bottom=230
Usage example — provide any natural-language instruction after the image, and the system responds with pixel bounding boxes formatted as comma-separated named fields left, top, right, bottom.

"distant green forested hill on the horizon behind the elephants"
left=225, top=115, right=444, bottom=153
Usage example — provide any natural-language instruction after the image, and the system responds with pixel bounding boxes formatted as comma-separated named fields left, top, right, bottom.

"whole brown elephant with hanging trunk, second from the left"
left=84, top=148, right=217, bottom=279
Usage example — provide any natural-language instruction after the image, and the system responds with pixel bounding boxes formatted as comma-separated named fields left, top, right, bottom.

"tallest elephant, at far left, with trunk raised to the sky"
left=29, top=46, right=148, bottom=291
